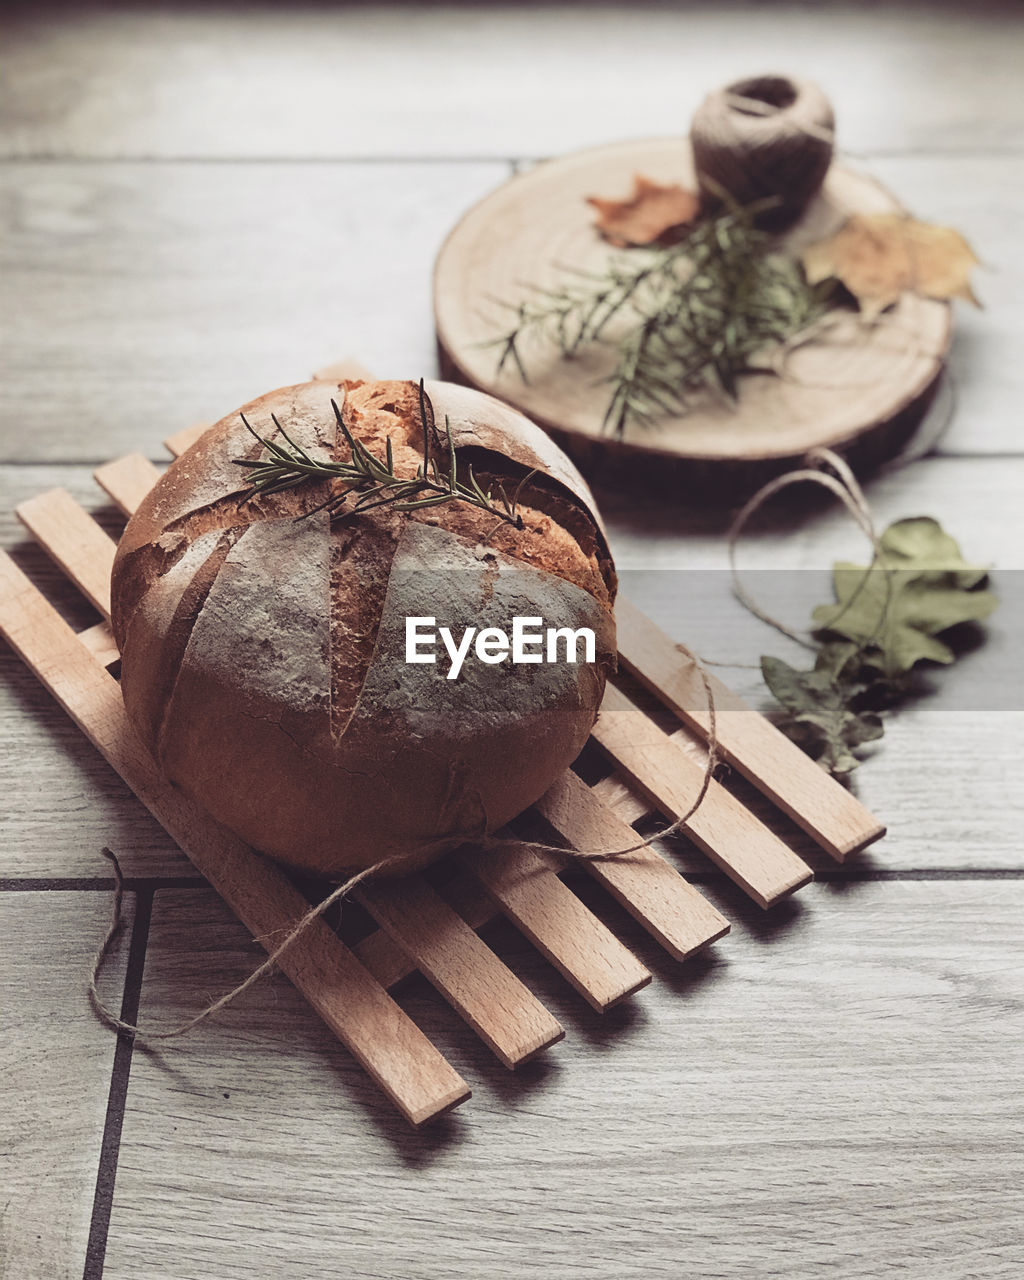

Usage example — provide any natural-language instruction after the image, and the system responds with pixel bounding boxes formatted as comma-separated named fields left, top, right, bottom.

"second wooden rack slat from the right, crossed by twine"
left=593, top=685, right=814, bottom=908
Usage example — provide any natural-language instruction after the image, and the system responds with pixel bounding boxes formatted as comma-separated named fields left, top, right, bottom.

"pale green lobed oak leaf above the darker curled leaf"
left=813, top=516, right=996, bottom=680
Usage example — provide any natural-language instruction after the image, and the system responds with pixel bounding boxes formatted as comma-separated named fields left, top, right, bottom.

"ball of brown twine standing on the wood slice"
left=690, top=76, right=836, bottom=228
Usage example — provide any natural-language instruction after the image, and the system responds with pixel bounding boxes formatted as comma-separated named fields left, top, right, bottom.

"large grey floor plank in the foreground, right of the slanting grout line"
left=105, top=881, right=1024, bottom=1280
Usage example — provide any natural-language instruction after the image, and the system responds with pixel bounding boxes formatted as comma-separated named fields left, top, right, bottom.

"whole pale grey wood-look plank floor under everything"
left=0, top=4, right=1024, bottom=1280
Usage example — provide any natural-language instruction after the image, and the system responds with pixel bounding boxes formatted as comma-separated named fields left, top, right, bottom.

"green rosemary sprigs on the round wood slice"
left=483, top=202, right=831, bottom=438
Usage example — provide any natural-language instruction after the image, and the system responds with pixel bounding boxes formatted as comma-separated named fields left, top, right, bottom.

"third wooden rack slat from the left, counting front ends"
left=461, top=845, right=650, bottom=1012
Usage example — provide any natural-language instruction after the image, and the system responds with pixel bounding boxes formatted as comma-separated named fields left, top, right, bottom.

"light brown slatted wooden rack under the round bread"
left=0, top=366, right=883, bottom=1125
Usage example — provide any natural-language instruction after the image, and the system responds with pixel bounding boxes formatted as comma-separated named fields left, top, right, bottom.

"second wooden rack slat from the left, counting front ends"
left=356, top=876, right=564, bottom=1070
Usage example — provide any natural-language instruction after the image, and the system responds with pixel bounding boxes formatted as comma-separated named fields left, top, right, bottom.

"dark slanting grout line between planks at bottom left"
left=82, top=882, right=154, bottom=1280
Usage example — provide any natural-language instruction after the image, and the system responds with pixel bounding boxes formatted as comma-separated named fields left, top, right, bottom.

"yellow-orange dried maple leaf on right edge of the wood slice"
left=801, top=214, right=979, bottom=319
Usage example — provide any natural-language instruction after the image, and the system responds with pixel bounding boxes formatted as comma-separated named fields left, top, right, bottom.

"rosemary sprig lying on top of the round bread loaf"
left=232, top=379, right=536, bottom=529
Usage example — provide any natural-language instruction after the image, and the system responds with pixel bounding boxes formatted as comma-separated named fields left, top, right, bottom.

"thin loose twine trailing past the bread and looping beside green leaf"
left=88, top=449, right=882, bottom=1044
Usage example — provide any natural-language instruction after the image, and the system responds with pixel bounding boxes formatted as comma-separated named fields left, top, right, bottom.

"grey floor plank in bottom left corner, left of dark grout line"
left=0, top=891, right=133, bottom=1280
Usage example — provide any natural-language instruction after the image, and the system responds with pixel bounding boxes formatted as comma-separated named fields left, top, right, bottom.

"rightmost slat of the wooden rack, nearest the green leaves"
left=616, top=596, right=886, bottom=860
